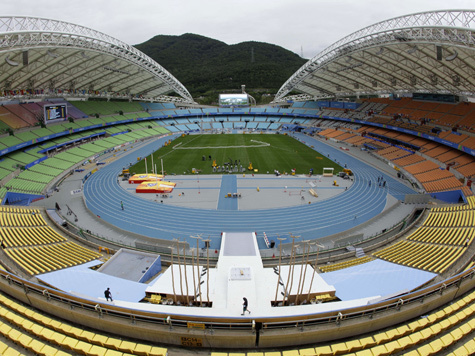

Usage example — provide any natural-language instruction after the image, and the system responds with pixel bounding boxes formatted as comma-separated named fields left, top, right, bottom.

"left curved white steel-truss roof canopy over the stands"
left=0, top=17, right=193, bottom=102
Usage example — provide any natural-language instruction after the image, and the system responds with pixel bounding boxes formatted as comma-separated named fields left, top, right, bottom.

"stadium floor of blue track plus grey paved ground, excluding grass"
left=35, top=135, right=414, bottom=252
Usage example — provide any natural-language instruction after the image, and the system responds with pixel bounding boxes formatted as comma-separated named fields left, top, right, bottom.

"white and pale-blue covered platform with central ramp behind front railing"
left=38, top=232, right=436, bottom=319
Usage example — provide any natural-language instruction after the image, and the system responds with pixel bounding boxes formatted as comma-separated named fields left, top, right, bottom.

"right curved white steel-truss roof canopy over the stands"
left=275, top=10, right=475, bottom=101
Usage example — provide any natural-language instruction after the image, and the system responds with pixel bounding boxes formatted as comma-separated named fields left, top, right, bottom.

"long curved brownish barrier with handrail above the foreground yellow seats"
left=0, top=268, right=475, bottom=330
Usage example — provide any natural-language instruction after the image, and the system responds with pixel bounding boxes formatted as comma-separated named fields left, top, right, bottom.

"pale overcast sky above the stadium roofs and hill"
left=2, top=0, right=475, bottom=58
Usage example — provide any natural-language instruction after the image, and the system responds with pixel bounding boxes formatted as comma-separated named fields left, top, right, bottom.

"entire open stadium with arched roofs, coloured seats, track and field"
left=0, top=10, right=475, bottom=356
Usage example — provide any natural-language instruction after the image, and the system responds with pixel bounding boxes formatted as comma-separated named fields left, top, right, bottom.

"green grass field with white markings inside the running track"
left=130, top=134, right=342, bottom=174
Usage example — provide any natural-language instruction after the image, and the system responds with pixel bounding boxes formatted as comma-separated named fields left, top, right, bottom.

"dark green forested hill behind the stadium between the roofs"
left=135, top=34, right=307, bottom=97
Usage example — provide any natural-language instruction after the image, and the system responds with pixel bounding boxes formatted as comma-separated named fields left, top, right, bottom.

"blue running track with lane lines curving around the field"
left=84, top=134, right=415, bottom=248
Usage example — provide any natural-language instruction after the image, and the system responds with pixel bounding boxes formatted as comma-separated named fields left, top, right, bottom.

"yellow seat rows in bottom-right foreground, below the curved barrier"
left=198, top=292, right=475, bottom=356
